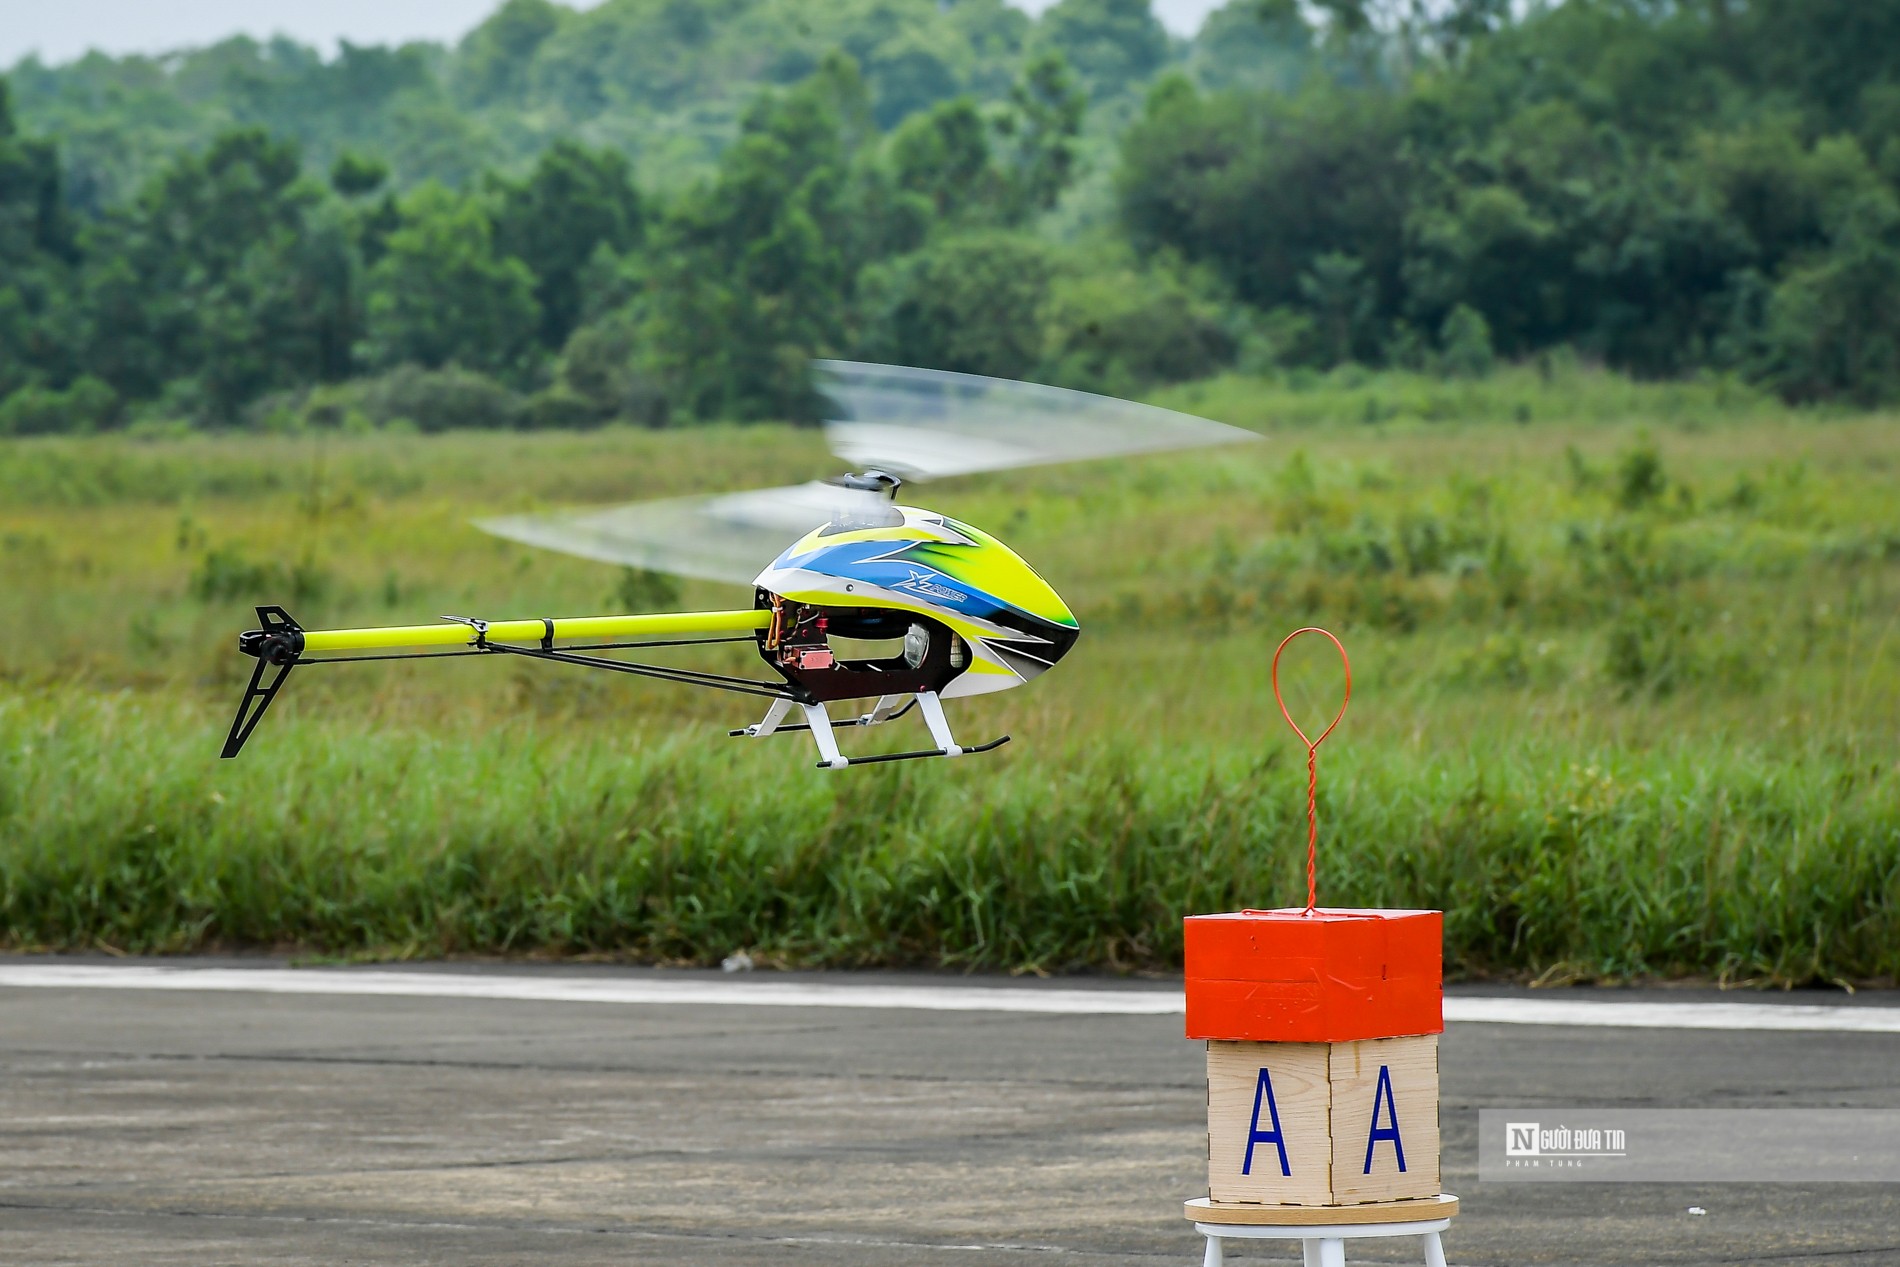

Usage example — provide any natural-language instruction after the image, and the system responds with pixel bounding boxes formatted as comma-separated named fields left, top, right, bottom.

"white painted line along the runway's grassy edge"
left=0, top=961, right=1900, bottom=1033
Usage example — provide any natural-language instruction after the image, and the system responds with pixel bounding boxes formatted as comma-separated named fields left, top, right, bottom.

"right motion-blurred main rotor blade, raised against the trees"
left=811, top=361, right=1260, bottom=481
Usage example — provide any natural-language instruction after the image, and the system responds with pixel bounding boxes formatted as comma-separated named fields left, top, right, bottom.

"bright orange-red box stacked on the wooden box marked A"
left=1184, top=906, right=1444, bottom=1043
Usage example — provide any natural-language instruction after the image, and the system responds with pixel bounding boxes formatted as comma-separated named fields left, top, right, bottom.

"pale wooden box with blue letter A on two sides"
left=1207, top=1033, right=1438, bottom=1206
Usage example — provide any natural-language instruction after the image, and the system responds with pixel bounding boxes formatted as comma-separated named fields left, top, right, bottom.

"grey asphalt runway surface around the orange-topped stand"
left=0, top=959, right=1900, bottom=1267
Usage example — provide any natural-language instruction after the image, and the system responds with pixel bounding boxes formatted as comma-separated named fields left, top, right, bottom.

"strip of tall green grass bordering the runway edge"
left=0, top=693, right=1900, bottom=982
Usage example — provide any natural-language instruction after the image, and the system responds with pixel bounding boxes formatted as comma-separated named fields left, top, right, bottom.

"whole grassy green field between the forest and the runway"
left=0, top=365, right=1900, bottom=984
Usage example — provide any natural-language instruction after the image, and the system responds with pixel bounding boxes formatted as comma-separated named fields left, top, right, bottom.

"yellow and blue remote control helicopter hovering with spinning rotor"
left=222, top=361, right=1258, bottom=769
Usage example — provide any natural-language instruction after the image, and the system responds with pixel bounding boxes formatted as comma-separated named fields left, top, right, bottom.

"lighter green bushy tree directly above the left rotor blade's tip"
left=365, top=184, right=542, bottom=376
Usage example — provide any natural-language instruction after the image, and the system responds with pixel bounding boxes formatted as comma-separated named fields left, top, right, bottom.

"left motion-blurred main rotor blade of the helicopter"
left=475, top=481, right=884, bottom=585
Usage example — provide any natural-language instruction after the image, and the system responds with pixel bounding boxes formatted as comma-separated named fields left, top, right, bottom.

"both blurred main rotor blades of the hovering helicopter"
left=477, top=361, right=1260, bottom=583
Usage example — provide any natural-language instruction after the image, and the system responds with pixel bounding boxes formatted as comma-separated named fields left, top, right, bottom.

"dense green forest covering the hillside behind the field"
left=0, top=0, right=1900, bottom=433
